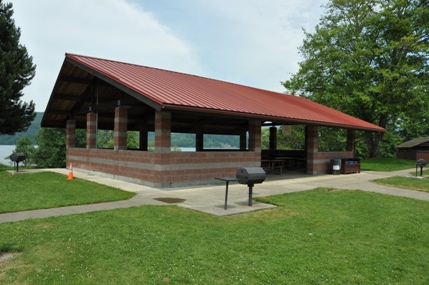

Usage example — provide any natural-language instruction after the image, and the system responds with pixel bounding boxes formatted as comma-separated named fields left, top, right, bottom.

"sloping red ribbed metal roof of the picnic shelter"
left=66, top=54, right=385, bottom=132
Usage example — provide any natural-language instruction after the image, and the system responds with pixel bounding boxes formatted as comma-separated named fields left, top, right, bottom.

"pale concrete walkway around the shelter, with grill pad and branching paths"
left=0, top=166, right=429, bottom=223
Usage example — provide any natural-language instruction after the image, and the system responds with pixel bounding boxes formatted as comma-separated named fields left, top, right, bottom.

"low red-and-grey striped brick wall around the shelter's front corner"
left=67, top=148, right=260, bottom=188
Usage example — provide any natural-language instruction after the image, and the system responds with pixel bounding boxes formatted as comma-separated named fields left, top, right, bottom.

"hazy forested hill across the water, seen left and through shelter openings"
left=0, top=112, right=240, bottom=148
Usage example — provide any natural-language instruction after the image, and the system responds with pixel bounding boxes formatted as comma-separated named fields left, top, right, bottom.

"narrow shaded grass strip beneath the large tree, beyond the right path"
left=361, top=158, right=416, bottom=171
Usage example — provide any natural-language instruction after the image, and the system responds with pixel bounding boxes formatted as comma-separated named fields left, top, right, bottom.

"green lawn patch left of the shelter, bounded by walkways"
left=0, top=171, right=135, bottom=213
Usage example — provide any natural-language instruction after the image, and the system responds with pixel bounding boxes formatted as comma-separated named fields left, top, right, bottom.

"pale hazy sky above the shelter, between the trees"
left=10, top=0, right=328, bottom=112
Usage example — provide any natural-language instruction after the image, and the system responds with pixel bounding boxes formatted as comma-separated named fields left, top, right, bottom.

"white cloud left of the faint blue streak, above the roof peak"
left=13, top=0, right=202, bottom=111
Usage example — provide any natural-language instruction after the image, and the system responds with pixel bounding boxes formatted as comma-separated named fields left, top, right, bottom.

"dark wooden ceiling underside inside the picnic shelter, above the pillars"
left=42, top=59, right=270, bottom=134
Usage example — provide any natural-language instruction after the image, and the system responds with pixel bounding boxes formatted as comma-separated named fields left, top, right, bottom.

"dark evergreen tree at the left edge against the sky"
left=0, top=0, right=36, bottom=135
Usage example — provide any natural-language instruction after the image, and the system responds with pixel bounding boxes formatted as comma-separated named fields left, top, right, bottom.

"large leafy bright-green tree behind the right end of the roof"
left=283, top=0, right=429, bottom=157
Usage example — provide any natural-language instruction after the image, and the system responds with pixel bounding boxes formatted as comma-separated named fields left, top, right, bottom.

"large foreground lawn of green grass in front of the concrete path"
left=0, top=189, right=429, bottom=285
